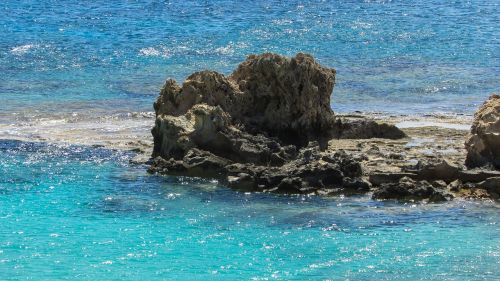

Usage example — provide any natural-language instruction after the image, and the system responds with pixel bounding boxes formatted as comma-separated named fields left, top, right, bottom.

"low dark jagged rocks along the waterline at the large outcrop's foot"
left=150, top=140, right=364, bottom=193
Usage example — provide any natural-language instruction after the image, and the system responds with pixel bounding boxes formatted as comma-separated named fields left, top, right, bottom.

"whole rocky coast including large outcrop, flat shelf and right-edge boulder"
left=149, top=54, right=500, bottom=202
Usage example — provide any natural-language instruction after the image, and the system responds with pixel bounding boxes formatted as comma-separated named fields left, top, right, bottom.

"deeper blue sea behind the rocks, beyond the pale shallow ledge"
left=0, top=0, right=500, bottom=114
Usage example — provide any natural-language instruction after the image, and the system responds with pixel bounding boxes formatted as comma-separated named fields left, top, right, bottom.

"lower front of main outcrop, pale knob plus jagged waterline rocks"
left=150, top=100, right=369, bottom=193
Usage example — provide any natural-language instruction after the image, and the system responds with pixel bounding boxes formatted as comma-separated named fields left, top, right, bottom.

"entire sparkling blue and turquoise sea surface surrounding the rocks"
left=0, top=0, right=500, bottom=280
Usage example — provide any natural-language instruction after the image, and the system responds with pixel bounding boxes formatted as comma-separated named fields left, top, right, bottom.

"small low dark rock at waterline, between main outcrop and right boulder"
left=373, top=177, right=452, bottom=202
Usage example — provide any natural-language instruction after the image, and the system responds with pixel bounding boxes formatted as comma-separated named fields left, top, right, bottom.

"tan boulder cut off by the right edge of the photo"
left=465, top=95, right=500, bottom=169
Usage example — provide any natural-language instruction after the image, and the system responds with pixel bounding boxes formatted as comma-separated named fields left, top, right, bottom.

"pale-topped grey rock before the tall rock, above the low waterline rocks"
left=152, top=104, right=294, bottom=165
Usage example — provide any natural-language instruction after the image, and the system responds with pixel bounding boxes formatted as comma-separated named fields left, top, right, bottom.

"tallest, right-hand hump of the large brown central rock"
left=230, top=53, right=335, bottom=144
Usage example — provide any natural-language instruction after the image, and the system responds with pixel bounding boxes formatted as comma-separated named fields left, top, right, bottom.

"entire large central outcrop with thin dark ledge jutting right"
left=150, top=54, right=404, bottom=194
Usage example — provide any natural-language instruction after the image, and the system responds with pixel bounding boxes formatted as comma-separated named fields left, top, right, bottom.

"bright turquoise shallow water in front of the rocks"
left=0, top=141, right=500, bottom=280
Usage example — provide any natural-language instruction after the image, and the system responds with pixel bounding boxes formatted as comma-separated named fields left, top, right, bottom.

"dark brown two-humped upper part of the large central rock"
left=154, top=53, right=336, bottom=149
